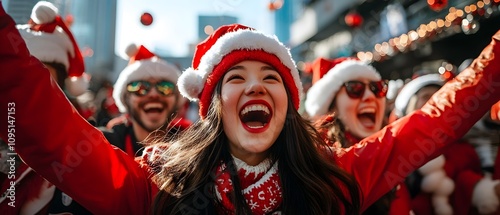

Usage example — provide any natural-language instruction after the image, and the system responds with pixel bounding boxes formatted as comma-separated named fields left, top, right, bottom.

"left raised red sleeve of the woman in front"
left=0, top=6, right=153, bottom=214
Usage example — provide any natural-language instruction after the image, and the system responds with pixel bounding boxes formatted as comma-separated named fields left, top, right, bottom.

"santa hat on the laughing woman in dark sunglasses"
left=305, top=57, right=382, bottom=117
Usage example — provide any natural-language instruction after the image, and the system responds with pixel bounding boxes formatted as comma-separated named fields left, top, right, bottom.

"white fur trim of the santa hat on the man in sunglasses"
left=113, top=57, right=180, bottom=113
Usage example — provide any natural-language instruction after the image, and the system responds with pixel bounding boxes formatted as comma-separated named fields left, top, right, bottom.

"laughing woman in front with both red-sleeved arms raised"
left=0, top=4, right=500, bottom=214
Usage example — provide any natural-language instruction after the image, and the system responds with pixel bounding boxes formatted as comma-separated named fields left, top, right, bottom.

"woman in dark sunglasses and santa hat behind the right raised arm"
left=305, top=57, right=411, bottom=215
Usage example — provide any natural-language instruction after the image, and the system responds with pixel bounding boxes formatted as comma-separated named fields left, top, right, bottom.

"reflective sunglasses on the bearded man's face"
left=127, top=81, right=175, bottom=96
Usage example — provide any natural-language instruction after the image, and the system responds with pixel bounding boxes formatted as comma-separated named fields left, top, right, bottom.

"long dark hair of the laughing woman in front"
left=152, top=76, right=361, bottom=214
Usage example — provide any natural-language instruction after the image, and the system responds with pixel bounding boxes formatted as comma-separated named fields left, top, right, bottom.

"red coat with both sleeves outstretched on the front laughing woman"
left=0, top=5, right=500, bottom=214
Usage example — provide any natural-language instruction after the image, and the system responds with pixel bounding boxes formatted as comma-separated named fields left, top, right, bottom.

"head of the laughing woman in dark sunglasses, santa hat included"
left=305, top=58, right=387, bottom=147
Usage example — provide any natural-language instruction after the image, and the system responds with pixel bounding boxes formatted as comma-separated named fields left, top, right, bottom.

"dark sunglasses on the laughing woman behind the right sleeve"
left=344, top=80, right=387, bottom=99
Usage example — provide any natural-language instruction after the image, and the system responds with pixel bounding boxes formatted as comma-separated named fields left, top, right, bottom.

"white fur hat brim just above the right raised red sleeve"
left=394, top=74, right=444, bottom=118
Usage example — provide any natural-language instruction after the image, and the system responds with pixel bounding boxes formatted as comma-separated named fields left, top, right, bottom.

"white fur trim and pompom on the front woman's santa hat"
left=177, top=29, right=302, bottom=101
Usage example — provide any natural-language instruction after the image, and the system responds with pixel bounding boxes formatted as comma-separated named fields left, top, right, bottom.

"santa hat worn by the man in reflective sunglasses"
left=113, top=44, right=184, bottom=113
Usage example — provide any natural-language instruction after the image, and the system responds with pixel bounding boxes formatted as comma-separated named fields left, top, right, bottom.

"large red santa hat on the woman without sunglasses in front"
left=178, top=24, right=302, bottom=119
